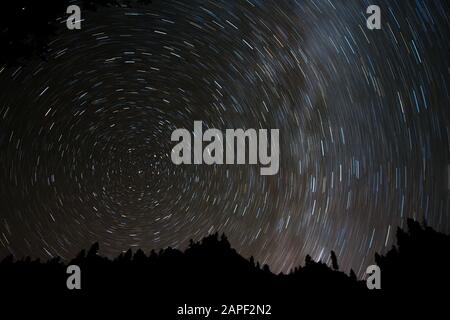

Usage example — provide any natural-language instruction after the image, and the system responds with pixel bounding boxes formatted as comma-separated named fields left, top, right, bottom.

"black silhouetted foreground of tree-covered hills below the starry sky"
left=0, top=220, right=450, bottom=319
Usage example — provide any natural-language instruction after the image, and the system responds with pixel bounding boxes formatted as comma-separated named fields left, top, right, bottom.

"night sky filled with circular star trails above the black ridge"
left=0, top=0, right=450, bottom=275
